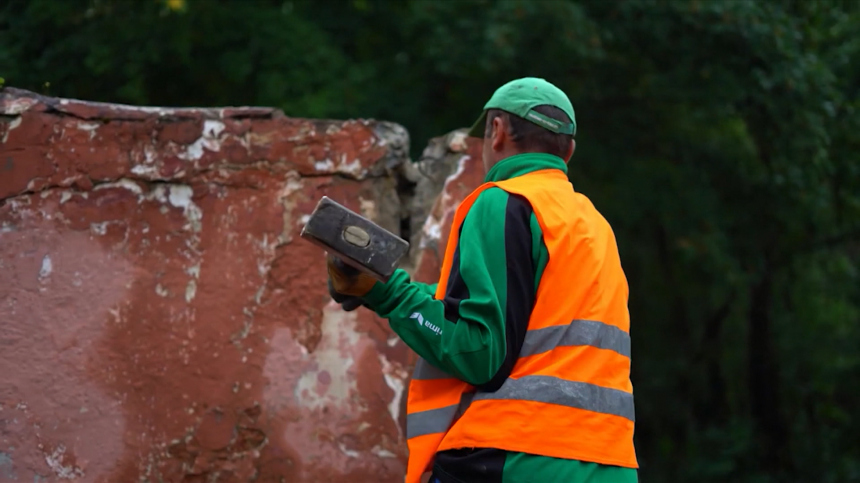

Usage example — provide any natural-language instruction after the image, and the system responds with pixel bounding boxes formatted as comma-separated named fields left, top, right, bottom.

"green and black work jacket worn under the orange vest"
left=364, top=153, right=638, bottom=483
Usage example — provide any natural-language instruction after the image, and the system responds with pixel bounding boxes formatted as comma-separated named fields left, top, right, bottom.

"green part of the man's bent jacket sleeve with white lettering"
left=365, top=188, right=512, bottom=385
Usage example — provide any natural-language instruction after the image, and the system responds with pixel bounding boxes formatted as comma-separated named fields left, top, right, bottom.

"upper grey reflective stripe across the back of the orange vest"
left=520, top=320, right=630, bottom=357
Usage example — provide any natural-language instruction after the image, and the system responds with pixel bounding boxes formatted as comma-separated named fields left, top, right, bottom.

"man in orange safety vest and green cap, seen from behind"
left=328, top=78, right=638, bottom=483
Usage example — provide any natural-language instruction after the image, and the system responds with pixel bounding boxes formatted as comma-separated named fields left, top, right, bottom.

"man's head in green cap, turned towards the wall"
left=469, top=77, right=576, bottom=170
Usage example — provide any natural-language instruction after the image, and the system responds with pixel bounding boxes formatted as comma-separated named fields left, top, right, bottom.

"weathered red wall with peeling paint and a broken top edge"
left=0, top=88, right=479, bottom=483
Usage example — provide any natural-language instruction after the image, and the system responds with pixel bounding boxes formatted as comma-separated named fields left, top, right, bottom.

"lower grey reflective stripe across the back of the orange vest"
left=474, top=376, right=636, bottom=422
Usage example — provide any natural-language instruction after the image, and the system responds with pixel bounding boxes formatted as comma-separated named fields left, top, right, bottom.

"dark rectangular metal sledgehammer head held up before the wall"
left=301, top=196, right=409, bottom=282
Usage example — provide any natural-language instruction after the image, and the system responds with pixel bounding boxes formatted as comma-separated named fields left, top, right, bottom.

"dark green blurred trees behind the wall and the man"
left=0, top=0, right=860, bottom=483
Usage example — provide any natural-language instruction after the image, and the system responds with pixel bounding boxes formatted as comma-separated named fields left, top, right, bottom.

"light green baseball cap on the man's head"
left=468, top=77, right=576, bottom=138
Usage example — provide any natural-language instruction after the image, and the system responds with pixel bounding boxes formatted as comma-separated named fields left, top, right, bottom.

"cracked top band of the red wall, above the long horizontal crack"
left=0, top=87, right=409, bottom=199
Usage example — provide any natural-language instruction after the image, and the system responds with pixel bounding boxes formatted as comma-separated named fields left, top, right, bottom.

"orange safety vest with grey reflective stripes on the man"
left=406, top=169, right=638, bottom=483
